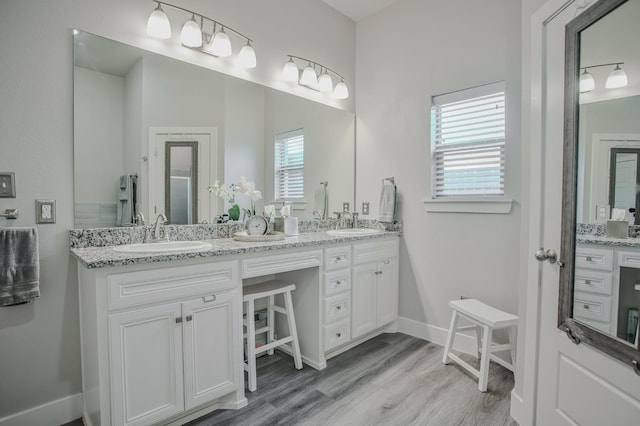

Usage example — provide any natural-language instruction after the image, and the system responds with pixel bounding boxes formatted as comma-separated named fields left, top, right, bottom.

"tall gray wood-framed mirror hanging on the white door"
left=558, top=0, right=640, bottom=374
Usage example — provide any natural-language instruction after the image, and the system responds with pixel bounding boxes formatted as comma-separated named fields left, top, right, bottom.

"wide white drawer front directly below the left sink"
left=107, top=261, right=240, bottom=309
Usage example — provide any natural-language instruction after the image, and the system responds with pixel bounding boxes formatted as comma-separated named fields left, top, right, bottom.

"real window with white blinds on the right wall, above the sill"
left=431, top=82, right=505, bottom=198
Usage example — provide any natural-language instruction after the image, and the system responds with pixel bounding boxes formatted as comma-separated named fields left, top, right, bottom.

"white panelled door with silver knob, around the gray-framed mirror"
left=519, top=0, right=640, bottom=426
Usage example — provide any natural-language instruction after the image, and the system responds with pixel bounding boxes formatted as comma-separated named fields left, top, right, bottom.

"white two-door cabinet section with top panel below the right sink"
left=351, top=239, right=399, bottom=339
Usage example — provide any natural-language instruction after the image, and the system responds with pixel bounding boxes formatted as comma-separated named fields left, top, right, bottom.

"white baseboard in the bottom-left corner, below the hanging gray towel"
left=0, top=393, right=82, bottom=426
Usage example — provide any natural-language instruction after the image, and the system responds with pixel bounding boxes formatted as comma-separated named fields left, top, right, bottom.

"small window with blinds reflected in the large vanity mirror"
left=274, top=129, right=304, bottom=200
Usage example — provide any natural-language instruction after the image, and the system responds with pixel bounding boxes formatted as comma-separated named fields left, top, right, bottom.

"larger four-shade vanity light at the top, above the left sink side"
left=147, top=0, right=256, bottom=68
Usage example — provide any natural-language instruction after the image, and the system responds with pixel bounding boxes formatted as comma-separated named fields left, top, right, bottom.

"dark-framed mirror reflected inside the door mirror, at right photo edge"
left=609, top=148, right=640, bottom=225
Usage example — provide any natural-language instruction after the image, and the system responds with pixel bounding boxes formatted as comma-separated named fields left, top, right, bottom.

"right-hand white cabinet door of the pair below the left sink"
left=182, top=292, right=242, bottom=410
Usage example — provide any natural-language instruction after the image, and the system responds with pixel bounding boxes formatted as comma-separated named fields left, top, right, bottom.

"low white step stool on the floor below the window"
left=442, top=299, right=518, bottom=392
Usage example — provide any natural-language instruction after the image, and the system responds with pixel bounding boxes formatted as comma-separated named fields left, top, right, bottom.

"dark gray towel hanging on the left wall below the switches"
left=0, top=227, right=40, bottom=306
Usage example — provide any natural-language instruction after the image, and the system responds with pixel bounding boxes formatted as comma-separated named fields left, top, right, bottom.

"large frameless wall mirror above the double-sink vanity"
left=73, top=31, right=355, bottom=228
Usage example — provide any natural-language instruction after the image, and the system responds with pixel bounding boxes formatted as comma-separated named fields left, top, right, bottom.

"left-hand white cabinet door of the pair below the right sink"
left=351, top=263, right=378, bottom=339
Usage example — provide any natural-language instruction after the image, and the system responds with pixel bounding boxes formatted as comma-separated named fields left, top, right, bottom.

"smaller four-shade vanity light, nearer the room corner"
left=282, top=55, right=349, bottom=99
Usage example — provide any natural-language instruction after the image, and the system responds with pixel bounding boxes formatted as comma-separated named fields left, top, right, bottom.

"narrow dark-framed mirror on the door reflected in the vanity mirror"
left=164, top=141, right=198, bottom=225
